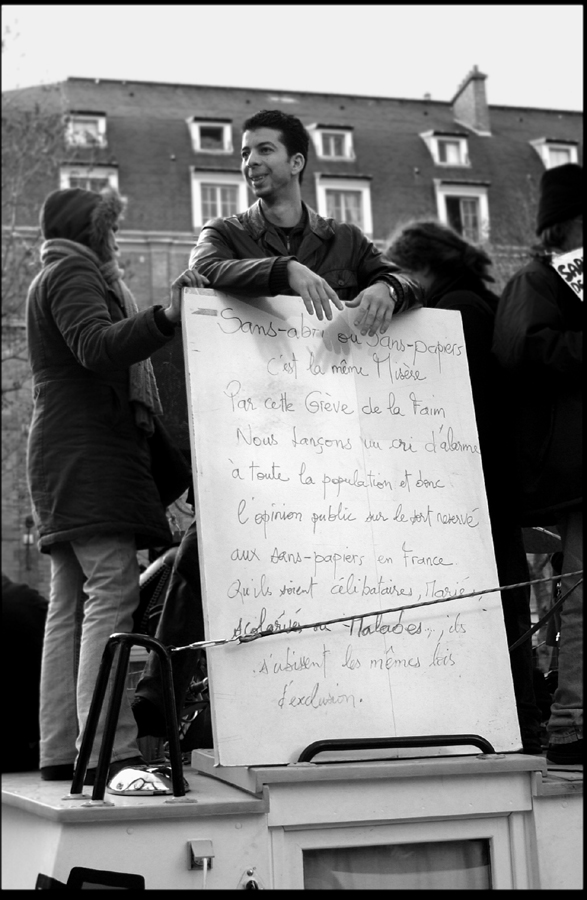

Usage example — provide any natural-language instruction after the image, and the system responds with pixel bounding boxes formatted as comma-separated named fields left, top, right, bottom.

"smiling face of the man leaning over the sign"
left=241, top=128, right=304, bottom=199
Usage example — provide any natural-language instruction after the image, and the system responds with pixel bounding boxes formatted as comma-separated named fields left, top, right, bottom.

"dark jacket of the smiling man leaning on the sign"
left=190, top=201, right=420, bottom=311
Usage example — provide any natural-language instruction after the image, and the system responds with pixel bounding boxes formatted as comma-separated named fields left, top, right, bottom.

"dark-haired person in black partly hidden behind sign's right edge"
left=387, top=221, right=541, bottom=753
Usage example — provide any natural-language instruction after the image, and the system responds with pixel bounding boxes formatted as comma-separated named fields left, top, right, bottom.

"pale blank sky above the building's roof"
left=2, top=4, right=583, bottom=111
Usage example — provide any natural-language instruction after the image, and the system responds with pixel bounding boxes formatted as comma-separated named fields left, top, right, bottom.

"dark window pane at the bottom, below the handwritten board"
left=302, top=839, right=491, bottom=890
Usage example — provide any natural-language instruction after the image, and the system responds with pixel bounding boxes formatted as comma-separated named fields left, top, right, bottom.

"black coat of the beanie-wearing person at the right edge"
left=494, top=258, right=583, bottom=525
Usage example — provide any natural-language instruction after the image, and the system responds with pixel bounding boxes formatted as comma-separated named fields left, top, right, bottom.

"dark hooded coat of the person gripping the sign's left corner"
left=26, top=188, right=177, bottom=552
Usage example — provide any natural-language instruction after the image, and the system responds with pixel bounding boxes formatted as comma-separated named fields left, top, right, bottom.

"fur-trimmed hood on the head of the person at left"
left=40, top=188, right=125, bottom=262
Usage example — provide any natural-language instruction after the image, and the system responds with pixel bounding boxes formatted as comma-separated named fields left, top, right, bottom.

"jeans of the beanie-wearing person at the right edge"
left=546, top=510, right=583, bottom=744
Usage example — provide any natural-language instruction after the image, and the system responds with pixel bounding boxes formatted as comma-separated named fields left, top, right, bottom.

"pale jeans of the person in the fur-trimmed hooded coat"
left=40, top=534, right=140, bottom=767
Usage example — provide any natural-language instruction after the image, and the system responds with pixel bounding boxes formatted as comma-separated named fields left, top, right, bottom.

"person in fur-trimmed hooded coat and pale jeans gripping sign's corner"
left=26, top=188, right=205, bottom=781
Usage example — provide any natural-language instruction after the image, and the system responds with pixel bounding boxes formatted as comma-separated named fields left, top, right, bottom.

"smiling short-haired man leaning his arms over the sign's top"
left=190, top=110, right=420, bottom=335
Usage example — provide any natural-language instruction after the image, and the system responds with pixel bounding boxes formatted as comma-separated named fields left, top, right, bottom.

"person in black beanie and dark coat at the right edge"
left=493, top=163, right=583, bottom=764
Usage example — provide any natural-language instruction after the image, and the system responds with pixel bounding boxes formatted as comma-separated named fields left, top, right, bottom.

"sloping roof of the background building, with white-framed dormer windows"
left=3, top=78, right=583, bottom=239
